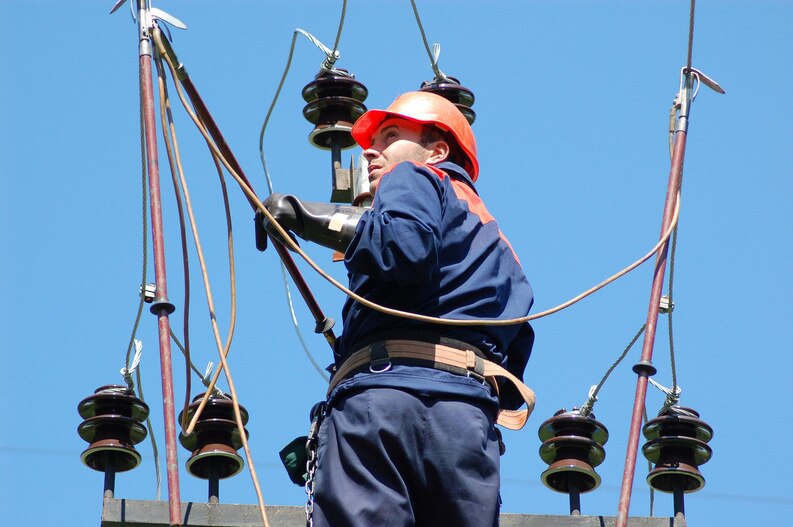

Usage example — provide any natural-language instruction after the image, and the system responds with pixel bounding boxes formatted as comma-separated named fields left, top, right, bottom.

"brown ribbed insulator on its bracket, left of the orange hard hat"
left=303, top=69, right=369, bottom=203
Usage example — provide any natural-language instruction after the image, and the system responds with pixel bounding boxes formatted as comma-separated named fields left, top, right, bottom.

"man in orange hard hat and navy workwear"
left=266, top=92, right=534, bottom=527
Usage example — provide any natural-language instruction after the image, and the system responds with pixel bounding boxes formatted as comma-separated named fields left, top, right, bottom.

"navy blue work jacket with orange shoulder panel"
left=336, top=162, right=534, bottom=408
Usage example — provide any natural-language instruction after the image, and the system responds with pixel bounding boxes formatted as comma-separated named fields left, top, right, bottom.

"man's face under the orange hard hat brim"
left=363, top=119, right=440, bottom=195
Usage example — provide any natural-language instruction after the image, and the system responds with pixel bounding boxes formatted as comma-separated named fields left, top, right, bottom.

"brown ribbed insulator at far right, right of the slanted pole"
left=642, top=406, right=713, bottom=506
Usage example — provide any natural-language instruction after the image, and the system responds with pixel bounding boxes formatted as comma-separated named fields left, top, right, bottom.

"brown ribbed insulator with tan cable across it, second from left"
left=179, top=394, right=248, bottom=501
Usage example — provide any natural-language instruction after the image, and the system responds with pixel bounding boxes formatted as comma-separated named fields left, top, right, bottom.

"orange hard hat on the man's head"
left=352, top=91, right=479, bottom=181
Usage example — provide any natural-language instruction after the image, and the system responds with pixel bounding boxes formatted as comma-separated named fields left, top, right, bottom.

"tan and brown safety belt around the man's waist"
left=328, top=339, right=536, bottom=430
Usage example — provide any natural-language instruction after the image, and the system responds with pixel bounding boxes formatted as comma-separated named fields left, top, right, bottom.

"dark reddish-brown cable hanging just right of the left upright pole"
left=154, top=58, right=193, bottom=430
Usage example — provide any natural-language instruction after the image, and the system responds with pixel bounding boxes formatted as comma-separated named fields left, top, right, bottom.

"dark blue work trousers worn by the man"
left=314, top=387, right=501, bottom=527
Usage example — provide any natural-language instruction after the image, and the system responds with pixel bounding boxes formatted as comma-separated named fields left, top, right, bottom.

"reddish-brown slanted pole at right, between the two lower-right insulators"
left=615, top=125, right=688, bottom=527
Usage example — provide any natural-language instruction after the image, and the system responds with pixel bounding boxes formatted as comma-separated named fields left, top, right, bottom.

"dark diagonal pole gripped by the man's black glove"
left=154, top=28, right=336, bottom=348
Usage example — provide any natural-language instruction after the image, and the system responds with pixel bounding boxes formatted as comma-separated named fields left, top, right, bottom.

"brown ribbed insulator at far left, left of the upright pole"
left=77, top=385, right=149, bottom=496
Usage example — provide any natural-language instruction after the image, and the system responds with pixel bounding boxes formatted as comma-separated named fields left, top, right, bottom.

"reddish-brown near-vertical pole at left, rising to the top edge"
left=137, top=0, right=182, bottom=526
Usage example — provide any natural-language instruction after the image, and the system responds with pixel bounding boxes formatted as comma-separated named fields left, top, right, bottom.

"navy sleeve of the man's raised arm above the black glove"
left=345, top=162, right=443, bottom=286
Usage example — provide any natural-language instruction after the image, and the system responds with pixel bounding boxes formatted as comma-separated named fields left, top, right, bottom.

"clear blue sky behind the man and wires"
left=0, top=0, right=793, bottom=527
